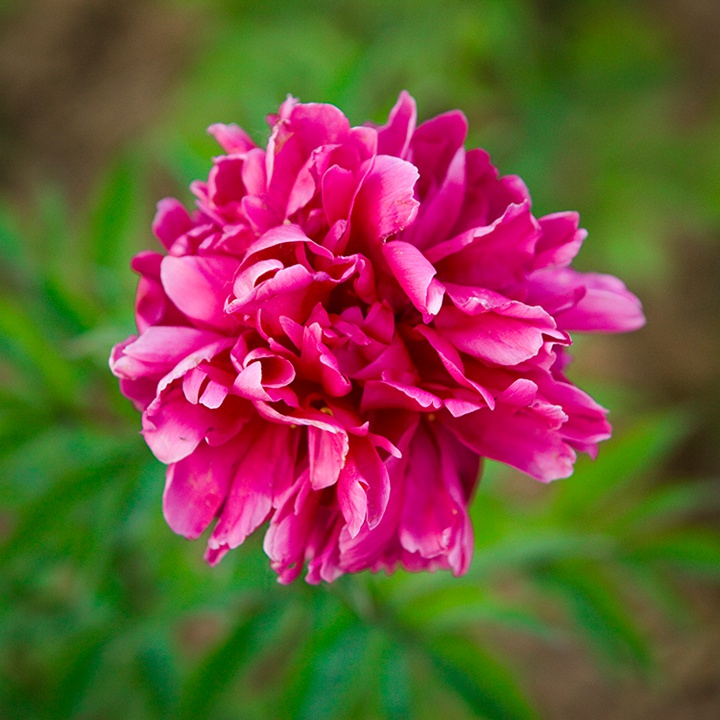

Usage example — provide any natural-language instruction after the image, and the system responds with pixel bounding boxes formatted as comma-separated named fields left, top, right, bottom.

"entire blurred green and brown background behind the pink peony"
left=0, top=0, right=720, bottom=720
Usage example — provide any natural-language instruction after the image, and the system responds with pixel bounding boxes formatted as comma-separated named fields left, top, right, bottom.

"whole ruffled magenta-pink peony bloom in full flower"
left=110, top=92, right=644, bottom=583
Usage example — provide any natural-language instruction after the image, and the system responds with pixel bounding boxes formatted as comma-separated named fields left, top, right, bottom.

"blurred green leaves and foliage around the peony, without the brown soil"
left=0, top=0, right=720, bottom=720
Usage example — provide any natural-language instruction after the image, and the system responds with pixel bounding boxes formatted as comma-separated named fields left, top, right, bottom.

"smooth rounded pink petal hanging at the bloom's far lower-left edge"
left=163, top=443, right=232, bottom=540
